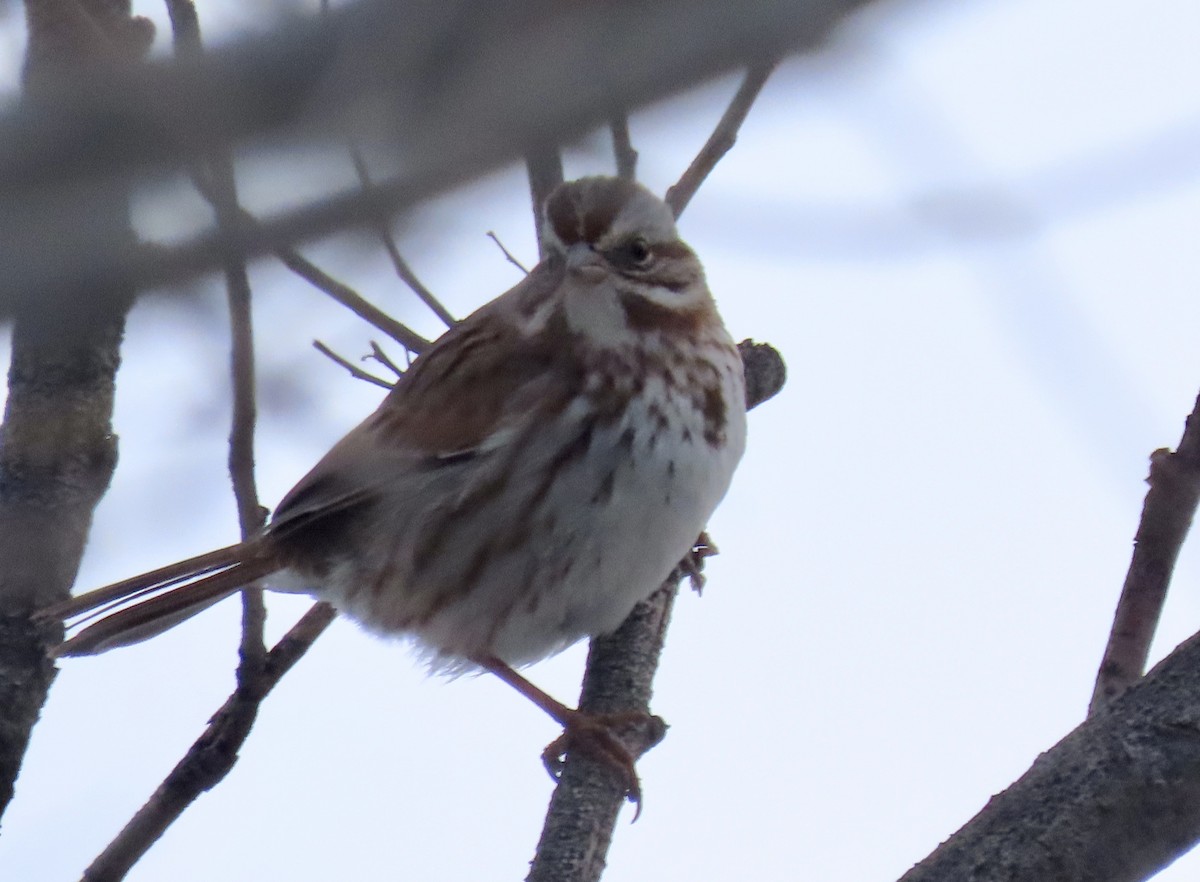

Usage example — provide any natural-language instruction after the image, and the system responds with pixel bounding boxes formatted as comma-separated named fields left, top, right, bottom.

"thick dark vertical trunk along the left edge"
left=0, top=0, right=152, bottom=812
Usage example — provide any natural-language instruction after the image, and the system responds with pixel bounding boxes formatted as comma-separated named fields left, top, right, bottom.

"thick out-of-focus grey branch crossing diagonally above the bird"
left=0, top=0, right=870, bottom=314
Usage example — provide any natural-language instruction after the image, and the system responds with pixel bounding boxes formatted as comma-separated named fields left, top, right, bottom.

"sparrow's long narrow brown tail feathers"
left=37, top=542, right=280, bottom=658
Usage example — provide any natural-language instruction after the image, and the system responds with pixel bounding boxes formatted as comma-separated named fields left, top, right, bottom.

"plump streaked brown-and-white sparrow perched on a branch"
left=42, top=178, right=745, bottom=811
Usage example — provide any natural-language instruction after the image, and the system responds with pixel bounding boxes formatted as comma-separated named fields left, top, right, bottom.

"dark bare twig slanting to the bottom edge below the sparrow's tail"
left=83, top=604, right=336, bottom=882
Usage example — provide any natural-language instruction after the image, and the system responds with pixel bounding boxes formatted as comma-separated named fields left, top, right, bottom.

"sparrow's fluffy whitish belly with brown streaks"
left=302, top=388, right=742, bottom=665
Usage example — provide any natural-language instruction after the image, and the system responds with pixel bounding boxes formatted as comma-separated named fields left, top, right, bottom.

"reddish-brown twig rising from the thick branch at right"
left=1088, top=388, right=1200, bottom=714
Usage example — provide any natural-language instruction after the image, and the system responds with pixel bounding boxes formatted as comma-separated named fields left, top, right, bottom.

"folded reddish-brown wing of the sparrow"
left=271, top=263, right=582, bottom=544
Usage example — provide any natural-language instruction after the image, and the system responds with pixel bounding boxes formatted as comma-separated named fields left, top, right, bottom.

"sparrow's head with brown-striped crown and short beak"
left=542, top=176, right=712, bottom=321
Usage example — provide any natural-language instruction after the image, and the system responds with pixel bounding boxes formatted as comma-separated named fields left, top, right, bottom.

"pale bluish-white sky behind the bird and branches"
left=7, top=0, right=1200, bottom=882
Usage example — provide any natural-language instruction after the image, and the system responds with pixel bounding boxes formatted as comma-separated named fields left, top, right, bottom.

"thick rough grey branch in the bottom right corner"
left=902, top=637, right=1200, bottom=882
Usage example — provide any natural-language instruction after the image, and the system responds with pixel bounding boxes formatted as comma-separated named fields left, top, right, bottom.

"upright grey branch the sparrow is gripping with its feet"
left=526, top=340, right=786, bottom=882
